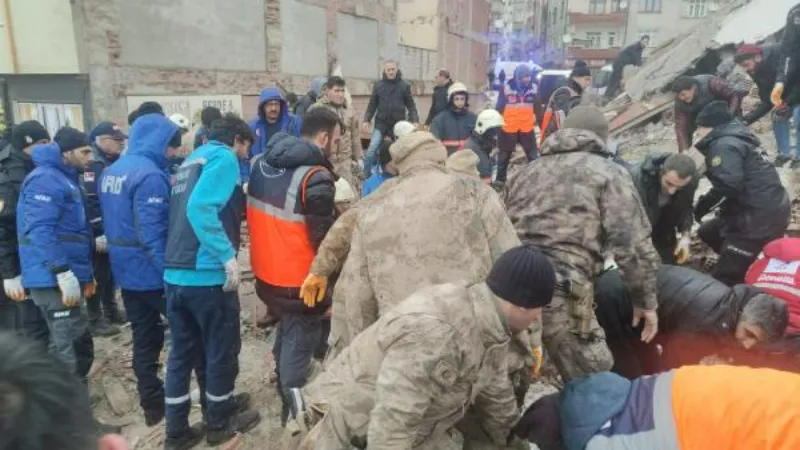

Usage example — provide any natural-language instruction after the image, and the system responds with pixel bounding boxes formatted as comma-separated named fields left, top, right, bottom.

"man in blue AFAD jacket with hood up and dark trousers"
left=98, top=114, right=181, bottom=427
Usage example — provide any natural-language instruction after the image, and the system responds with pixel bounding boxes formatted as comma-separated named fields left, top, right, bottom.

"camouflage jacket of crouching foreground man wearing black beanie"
left=304, top=283, right=518, bottom=450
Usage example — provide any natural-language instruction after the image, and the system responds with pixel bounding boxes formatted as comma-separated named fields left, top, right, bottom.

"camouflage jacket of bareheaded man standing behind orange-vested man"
left=309, top=95, right=364, bottom=193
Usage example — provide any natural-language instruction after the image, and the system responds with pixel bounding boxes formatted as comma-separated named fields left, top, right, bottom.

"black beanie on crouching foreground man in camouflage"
left=486, top=245, right=556, bottom=309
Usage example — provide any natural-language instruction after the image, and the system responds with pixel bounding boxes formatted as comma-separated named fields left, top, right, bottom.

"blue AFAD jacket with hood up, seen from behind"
left=100, top=114, right=178, bottom=291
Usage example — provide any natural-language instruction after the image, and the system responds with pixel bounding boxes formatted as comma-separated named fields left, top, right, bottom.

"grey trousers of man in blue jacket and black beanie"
left=31, top=288, right=91, bottom=376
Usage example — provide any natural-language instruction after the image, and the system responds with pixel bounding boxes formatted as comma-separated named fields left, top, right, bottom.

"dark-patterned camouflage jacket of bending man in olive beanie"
left=505, top=129, right=659, bottom=309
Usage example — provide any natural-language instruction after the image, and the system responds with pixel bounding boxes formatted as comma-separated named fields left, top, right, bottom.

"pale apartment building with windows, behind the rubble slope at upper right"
left=567, top=0, right=728, bottom=69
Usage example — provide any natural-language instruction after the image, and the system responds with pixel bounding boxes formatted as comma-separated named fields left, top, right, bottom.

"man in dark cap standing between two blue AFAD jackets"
left=81, top=122, right=128, bottom=336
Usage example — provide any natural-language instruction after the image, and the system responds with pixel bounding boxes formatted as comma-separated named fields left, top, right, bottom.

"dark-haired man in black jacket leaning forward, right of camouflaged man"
left=628, top=153, right=698, bottom=264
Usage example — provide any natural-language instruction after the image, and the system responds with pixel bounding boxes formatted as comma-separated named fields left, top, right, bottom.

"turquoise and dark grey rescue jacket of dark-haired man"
left=164, top=141, right=244, bottom=286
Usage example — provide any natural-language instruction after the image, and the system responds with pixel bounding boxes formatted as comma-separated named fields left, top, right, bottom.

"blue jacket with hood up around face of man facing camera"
left=240, top=88, right=300, bottom=183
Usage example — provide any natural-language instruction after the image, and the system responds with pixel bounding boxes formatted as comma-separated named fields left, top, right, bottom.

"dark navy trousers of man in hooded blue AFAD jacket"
left=122, top=289, right=167, bottom=410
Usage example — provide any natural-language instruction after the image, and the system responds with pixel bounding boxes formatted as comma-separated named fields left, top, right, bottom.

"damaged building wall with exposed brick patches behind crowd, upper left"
left=0, top=0, right=490, bottom=131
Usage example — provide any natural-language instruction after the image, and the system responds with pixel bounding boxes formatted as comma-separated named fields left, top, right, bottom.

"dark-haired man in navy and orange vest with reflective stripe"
left=247, top=108, right=343, bottom=422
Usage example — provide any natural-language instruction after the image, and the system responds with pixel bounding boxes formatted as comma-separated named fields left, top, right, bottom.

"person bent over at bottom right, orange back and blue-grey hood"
left=514, top=366, right=800, bottom=450
